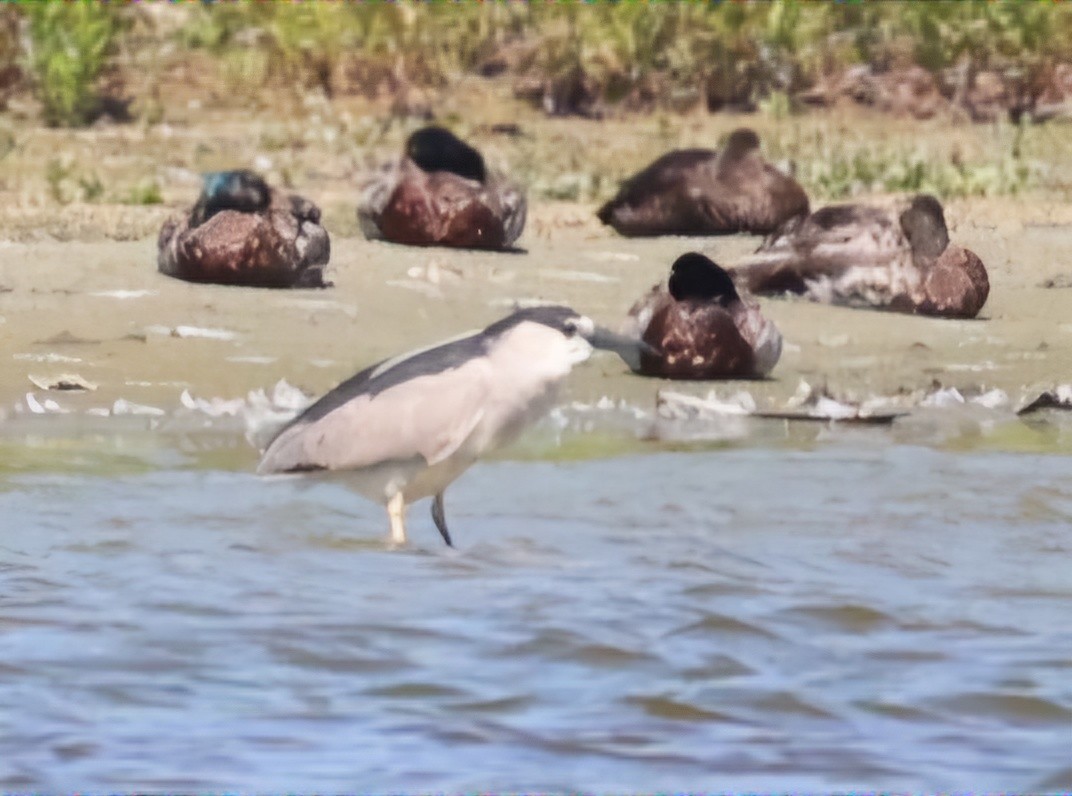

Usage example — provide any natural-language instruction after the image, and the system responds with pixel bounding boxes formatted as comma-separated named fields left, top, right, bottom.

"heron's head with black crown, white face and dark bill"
left=485, top=305, right=652, bottom=371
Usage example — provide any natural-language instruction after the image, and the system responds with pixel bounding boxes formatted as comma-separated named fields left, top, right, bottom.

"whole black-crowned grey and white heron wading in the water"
left=257, top=306, right=643, bottom=545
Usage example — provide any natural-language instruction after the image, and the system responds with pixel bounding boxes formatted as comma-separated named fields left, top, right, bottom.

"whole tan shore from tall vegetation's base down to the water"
left=0, top=94, right=1072, bottom=411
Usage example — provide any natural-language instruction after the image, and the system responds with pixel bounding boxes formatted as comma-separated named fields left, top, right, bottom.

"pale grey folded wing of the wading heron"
left=257, top=358, right=491, bottom=472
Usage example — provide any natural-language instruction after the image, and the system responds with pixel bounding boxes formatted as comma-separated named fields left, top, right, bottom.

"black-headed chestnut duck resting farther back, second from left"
left=357, top=126, right=526, bottom=249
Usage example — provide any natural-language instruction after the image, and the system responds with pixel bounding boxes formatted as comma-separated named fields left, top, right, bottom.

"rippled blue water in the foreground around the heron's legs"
left=0, top=426, right=1072, bottom=792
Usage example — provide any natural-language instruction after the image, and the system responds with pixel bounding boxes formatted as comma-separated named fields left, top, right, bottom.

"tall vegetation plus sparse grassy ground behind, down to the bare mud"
left=0, top=0, right=1072, bottom=217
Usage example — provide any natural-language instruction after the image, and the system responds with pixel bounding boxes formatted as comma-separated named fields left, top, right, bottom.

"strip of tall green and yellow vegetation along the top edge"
left=0, top=0, right=1072, bottom=118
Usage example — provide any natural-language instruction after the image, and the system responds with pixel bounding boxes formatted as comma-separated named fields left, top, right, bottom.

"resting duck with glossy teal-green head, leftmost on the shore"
left=157, top=170, right=331, bottom=287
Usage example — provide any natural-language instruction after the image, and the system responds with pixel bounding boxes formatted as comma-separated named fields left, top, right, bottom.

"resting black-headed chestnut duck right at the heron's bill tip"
left=625, top=252, right=781, bottom=379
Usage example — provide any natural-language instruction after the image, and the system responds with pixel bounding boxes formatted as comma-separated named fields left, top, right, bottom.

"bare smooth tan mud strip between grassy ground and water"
left=0, top=192, right=1072, bottom=424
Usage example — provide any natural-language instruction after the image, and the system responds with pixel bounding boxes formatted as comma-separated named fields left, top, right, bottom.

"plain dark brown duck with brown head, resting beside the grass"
left=598, top=127, right=808, bottom=237
